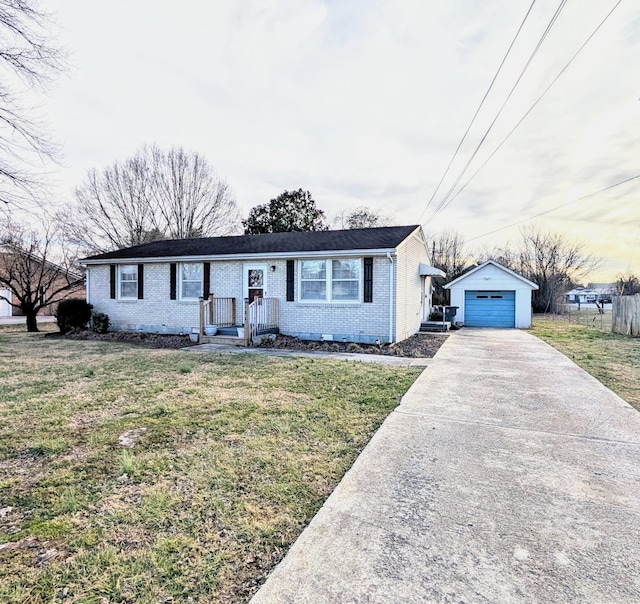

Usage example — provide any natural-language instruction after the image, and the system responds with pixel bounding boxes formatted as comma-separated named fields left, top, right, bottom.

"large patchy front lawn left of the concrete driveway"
left=0, top=327, right=419, bottom=603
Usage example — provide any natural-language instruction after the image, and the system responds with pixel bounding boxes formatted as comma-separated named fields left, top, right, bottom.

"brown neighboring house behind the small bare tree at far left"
left=0, top=245, right=85, bottom=317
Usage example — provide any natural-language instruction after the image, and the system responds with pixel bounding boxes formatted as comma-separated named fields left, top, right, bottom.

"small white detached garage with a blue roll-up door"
left=444, top=260, right=538, bottom=329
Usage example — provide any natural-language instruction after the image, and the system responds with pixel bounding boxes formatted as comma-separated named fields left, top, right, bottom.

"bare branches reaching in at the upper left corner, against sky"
left=0, top=0, right=62, bottom=209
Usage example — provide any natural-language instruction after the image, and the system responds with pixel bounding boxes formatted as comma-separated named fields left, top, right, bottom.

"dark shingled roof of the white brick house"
left=84, top=225, right=419, bottom=261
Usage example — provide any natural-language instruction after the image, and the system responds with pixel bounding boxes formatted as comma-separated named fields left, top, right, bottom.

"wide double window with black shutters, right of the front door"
left=300, top=258, right=362, bottom=302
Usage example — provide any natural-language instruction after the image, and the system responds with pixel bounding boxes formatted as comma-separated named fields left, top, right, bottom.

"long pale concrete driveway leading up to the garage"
left=252, top=329, right=640, bottom=604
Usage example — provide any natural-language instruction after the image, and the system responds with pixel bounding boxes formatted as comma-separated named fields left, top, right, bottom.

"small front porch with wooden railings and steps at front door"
left=198, top=294, right=280, bottom=346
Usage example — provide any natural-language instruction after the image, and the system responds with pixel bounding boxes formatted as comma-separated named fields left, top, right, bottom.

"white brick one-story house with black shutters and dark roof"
left=82, top=225, right=443, bottom=343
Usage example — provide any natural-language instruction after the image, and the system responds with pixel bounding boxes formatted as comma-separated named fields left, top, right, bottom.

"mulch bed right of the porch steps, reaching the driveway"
left=255, top=333, right=449, bottom=359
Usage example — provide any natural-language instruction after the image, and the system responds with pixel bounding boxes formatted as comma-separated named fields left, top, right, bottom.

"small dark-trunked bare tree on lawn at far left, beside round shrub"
left=0, top=218, right=84, bottom=331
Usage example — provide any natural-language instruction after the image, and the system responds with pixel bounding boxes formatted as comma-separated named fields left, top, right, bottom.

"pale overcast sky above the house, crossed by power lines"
left=38, top=0, right=640, bottom=281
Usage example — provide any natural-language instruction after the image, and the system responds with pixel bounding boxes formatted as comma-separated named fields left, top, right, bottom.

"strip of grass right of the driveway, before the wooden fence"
left=532, top=315, right=640, bottom=410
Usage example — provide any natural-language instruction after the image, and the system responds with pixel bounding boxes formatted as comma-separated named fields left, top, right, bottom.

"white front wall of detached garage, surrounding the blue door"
left=450, top=265, right=532, bottom=329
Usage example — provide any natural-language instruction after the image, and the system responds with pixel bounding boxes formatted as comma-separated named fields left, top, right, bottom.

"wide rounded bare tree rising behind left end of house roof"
left=63, top=145, right=239, bottom=253
